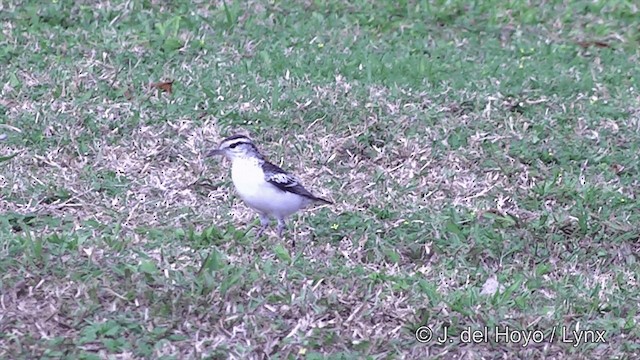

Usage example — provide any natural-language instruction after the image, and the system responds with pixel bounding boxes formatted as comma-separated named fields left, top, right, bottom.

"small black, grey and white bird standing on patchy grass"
left=207, top=135, right=332, bottom=238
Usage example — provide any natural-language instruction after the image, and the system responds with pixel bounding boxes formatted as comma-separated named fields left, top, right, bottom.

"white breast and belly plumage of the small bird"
left=231, top=158, right=310, bottom=218
